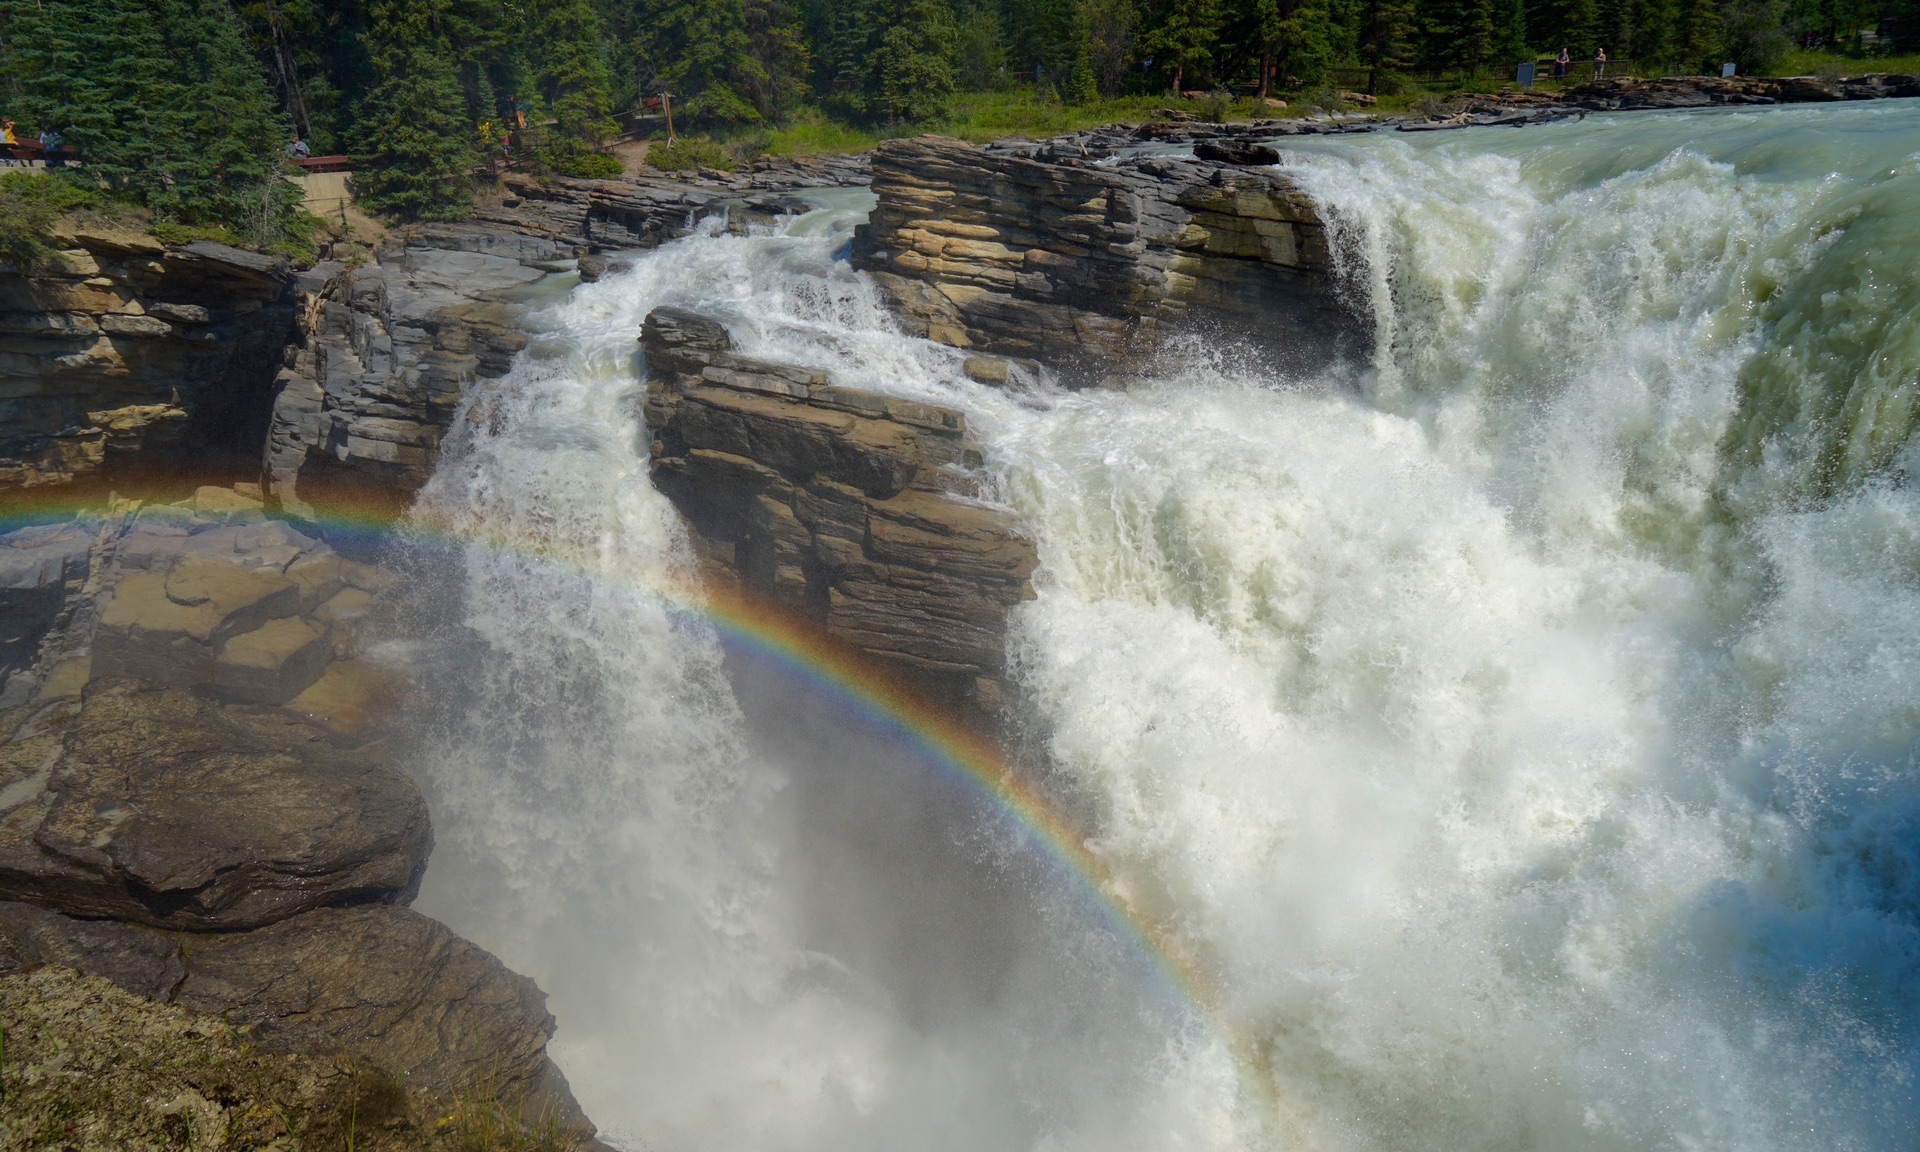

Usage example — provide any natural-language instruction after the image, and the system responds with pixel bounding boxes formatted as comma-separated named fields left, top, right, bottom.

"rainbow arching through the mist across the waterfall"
left=0, top=483, right=1298, bottom=1142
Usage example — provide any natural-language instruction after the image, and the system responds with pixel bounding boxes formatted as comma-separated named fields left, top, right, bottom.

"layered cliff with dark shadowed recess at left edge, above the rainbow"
left=0, top=225, right=294, bottom=490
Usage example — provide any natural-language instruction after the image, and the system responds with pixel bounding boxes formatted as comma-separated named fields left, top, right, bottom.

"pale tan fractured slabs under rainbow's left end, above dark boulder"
left=0, top=486, right=403, bottom=733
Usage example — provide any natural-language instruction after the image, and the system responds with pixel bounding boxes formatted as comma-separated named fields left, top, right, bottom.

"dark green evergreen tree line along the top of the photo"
left=0, top=0, right=1920, bottom=242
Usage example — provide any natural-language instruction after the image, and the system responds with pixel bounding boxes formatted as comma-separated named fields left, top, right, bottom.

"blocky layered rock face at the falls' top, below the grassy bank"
left=854, top=136, right=1348, bottom=376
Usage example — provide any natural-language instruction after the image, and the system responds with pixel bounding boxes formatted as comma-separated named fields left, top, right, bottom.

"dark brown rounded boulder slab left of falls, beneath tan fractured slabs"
left=0, top=682, right=432, bottom=931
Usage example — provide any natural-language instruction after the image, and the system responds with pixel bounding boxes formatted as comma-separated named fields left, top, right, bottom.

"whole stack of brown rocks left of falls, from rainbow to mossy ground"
left=0, top=488, right=591, bottom=1133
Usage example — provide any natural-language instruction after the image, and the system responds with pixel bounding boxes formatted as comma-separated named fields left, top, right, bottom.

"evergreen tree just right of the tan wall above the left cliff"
left=353, top=0, right=474, bottom=221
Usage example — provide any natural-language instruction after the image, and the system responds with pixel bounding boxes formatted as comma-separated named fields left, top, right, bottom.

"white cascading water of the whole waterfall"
left=405, top=102, right=1920, bottom=1150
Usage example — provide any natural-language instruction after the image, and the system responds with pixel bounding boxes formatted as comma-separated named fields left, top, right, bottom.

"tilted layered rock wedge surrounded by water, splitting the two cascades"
left=641, top=307, right=1035, bottom=707
